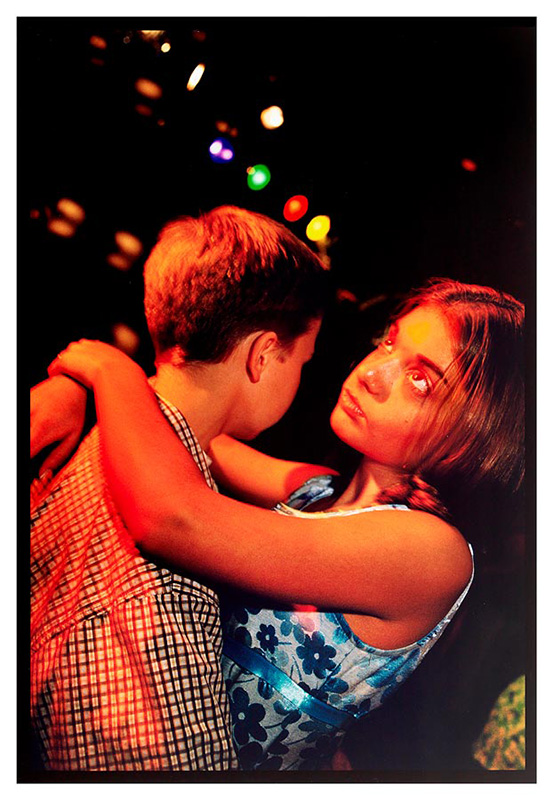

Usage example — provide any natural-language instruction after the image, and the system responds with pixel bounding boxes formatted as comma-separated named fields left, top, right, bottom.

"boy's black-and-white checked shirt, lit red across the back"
left=30, top=397, right=237, bottom=771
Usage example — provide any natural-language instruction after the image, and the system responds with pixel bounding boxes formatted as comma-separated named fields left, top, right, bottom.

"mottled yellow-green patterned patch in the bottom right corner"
left=473, top=675, right=525, bottom=769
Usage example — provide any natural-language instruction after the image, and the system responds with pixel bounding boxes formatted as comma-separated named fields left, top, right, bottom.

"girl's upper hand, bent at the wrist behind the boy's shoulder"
left=48, top=339, right=145, bottom=389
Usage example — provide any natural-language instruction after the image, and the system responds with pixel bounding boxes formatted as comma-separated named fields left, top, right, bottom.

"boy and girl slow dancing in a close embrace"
left=31, top=207, right=524, bottom=770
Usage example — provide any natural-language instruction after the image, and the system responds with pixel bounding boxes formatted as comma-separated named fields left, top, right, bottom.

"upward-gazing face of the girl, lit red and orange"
left=330, top=305, right=455, bottom=470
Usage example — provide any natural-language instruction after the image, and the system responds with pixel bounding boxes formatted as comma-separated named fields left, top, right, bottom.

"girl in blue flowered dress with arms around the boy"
left=43, top=280, right=524, bottom=769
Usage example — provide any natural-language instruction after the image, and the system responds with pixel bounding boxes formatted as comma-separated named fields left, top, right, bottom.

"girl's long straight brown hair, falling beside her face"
left=377, top=278, right=525, bottom=517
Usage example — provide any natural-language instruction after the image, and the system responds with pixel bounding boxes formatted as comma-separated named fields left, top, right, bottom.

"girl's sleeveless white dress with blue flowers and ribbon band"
left=222, top=476, right=473, bottom=770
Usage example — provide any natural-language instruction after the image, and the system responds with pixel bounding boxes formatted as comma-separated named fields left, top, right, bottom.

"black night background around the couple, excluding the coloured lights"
left=17, top=17, right=536, bottom=769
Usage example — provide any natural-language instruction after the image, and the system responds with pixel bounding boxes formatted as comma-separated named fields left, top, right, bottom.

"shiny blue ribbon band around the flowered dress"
left=222, top=639, right=355, bottom=728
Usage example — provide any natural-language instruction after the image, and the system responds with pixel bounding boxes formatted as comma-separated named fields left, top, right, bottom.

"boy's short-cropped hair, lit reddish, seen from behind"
left=144, top=206, right=328, bottom=362
